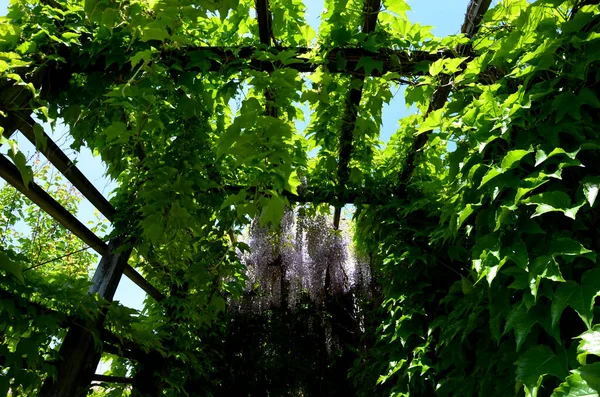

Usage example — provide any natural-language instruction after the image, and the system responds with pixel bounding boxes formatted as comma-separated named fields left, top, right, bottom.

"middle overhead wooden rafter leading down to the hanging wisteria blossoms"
left=333, top=0, right=381, bottom=229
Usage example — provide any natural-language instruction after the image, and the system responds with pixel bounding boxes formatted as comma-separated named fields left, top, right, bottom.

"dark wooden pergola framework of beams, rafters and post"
left=0, top=0, right=491, bottom=397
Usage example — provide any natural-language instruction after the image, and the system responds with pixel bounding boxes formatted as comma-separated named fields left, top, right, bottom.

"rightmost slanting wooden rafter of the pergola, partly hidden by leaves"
left=400, top=0, right=491, bottom=183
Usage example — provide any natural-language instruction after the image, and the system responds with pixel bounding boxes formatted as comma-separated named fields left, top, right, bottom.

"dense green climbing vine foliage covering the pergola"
left=0, top=0, right=600, bottom=397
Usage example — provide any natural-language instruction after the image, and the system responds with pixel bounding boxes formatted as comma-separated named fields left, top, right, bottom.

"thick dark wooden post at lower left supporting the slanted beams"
left=39, top=239, right=131, bottom=397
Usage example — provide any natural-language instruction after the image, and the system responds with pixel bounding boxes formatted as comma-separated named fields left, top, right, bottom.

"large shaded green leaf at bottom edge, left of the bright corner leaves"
left=515, top=345, right=568, bottom=396
